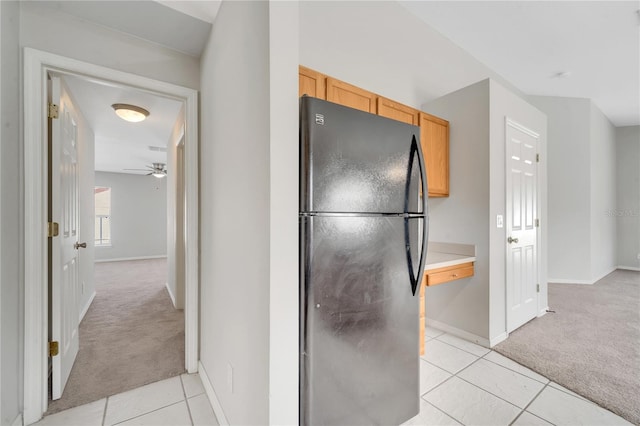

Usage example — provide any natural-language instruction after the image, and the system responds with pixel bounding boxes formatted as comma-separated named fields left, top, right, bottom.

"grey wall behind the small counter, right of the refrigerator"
left=423, top=80, right=491, bottom=340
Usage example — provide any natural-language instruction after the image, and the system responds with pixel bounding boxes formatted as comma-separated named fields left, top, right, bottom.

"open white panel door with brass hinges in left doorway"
left=49, top=77, right=80, bottom=399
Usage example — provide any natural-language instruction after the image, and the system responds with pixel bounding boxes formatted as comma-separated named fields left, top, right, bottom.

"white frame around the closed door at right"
left=504, top=116, right=546, bottom=337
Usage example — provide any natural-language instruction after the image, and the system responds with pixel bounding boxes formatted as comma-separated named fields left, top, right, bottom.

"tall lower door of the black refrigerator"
left=300, top=216, right=422, bottom=425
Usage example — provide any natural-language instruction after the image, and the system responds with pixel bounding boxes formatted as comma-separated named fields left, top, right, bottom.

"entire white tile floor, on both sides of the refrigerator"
left=36, top=327, right=630, bottom=426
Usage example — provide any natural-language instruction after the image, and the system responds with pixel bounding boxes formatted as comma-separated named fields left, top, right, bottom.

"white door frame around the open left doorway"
left=23, top=48, right=199, bottom=425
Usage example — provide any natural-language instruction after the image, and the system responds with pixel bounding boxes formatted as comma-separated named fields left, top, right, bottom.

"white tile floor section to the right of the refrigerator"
left=405, top=327, right=631, bottom=426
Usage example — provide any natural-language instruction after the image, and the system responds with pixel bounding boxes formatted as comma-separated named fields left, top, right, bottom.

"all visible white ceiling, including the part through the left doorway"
left=47, top=0, right=640, bottom=173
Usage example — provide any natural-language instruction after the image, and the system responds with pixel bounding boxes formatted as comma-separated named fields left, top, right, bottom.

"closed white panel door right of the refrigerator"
left=506, top=119, right=539, bottom=332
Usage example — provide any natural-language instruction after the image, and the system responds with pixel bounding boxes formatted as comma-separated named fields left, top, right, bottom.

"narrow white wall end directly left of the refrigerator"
left=269, top=2, right=300, bottom=425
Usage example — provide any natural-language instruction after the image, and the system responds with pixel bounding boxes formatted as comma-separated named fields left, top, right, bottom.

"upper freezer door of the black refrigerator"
left=300, top=97, right=426, bottom=213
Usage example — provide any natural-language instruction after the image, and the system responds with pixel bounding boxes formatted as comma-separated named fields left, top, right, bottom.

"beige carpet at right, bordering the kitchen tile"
left=493, top=270, right=640, bottom=424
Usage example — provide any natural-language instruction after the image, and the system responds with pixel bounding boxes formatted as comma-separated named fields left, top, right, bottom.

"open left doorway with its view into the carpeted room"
left=47, top=69, right=185, bottom=414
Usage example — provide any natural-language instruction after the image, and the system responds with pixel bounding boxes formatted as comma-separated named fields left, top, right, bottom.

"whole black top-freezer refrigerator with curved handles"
left=299, top=96, right=428, bottom=425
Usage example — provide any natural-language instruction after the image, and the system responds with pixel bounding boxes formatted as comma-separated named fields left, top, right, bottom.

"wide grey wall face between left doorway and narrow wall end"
left=200, top=2, right=270, bottom=424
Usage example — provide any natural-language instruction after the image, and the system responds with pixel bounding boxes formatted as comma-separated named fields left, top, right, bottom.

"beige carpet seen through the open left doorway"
left=47, top=259, right=184, bottom=414
